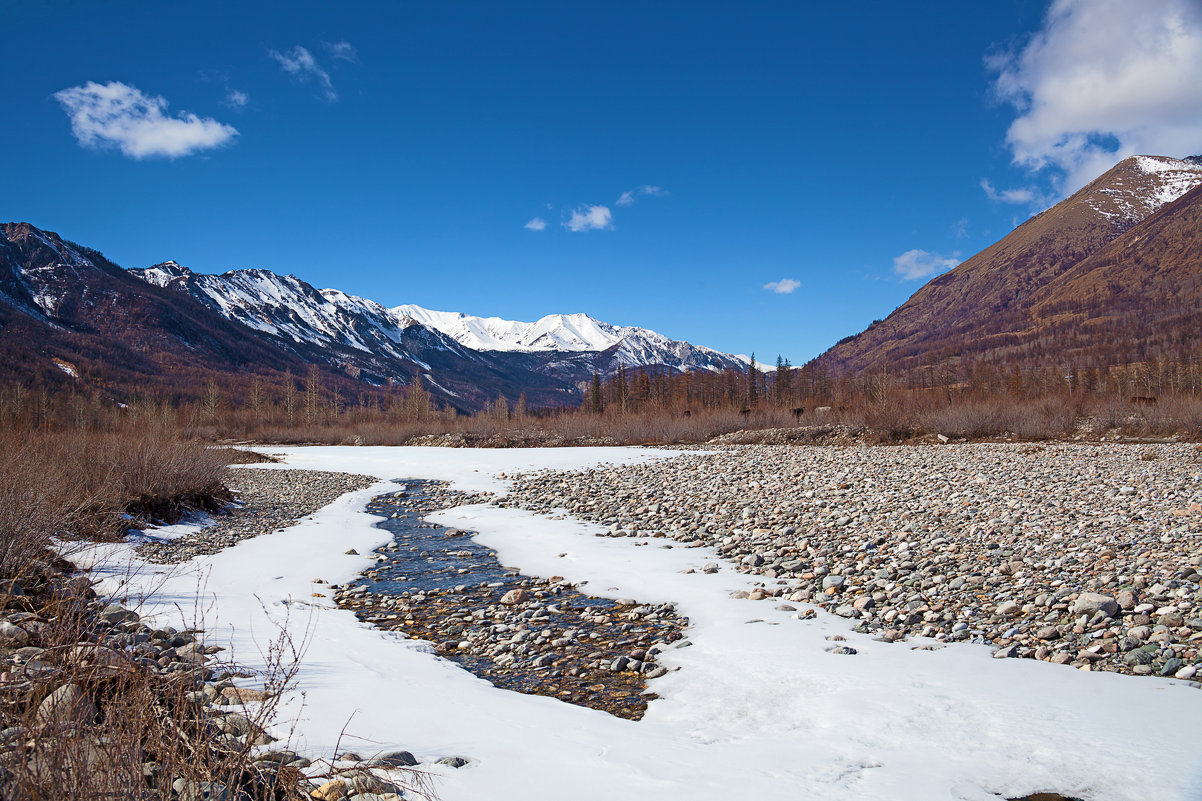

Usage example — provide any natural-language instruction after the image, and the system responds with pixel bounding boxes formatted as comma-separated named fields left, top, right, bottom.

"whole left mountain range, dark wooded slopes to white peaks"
left=0, top=223, right=746, bottom=411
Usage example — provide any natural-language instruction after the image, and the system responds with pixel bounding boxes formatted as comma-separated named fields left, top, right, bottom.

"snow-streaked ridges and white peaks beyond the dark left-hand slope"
left=130, top=261, right=746, bottom=375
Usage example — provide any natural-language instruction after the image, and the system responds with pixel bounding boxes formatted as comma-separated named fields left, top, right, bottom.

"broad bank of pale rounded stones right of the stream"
left=499, top=444, right=1202, bottom=680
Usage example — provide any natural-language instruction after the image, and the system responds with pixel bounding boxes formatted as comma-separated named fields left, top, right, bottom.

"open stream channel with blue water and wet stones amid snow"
left=331, top=481, right=688, bottom=720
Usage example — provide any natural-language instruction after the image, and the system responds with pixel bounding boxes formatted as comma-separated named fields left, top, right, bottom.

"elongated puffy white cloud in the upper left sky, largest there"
left=54, top=81, right=238, bottom=159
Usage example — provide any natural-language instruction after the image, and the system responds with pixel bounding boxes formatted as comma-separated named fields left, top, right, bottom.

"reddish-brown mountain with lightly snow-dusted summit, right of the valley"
left=814, top=156, right=1202, bottom=374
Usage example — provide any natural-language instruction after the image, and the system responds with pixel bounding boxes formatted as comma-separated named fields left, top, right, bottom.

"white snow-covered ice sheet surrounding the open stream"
left=82, top=447, right=1202, bottom=801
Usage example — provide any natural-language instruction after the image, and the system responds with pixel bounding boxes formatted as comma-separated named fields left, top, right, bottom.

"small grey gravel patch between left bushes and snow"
left=137, top=469, right=376, bottom=564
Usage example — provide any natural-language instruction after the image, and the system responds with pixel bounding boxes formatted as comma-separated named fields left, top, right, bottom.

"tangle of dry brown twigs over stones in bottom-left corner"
left=0, top=567, right=303, bottom=801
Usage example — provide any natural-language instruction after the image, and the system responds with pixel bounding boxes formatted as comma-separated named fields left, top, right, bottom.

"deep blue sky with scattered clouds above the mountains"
left=0, top=0, right=1202, bottom=363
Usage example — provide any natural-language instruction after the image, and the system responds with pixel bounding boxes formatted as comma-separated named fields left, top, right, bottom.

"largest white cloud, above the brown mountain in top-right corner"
left=986, top=0, right=1202, bottom=195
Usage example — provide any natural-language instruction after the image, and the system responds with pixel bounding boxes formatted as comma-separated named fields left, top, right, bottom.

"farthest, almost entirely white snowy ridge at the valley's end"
left=393, top=304, right=746, bottom=370
